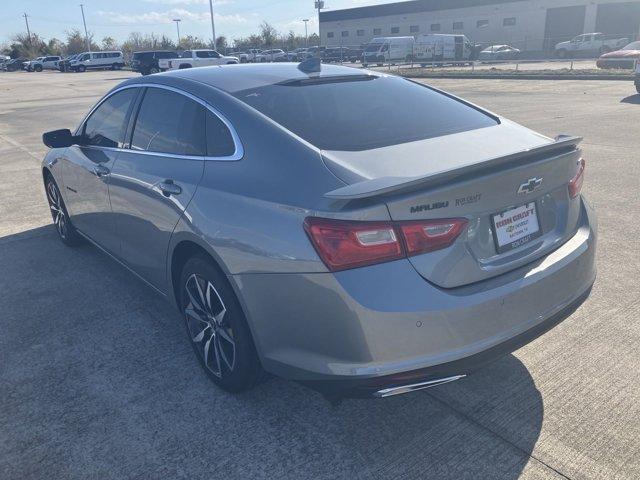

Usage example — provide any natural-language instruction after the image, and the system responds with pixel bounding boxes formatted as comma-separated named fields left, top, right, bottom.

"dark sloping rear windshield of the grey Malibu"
left=233, top=75, right=498, bottom=151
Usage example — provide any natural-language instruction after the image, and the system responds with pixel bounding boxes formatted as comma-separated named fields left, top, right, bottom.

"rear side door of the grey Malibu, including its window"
left=110, top=87, right=206, bottom=290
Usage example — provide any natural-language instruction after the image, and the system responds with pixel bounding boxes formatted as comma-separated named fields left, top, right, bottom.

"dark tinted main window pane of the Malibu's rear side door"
left=131, top=88, right=206, bottom=155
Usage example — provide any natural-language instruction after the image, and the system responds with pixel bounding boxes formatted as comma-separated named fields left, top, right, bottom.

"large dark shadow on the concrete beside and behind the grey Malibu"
left=0, top=226, right=549, bottom=480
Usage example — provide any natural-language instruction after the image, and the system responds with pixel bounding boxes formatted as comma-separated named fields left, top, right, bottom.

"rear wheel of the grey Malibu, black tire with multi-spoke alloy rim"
left=180, top=254, right=262, bottom=393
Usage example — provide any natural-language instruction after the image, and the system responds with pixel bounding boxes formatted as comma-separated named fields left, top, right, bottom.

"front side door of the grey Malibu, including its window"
left=62, top=89, right=137, bottom=253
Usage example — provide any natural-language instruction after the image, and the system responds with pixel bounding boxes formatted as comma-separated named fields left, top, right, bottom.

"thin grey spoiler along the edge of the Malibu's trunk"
left=324, top=135, right=582, bottom=200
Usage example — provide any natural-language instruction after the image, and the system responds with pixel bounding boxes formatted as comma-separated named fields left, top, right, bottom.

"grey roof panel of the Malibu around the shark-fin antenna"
left=154, top=63, right=381, bottom=93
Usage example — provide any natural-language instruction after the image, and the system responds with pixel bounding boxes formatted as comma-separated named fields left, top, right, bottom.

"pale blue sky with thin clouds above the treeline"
left=0, top=0, right=397, bottom=43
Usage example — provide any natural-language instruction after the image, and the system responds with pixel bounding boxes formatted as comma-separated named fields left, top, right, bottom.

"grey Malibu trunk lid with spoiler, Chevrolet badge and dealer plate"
left=324, top=121, right=580, bottom=288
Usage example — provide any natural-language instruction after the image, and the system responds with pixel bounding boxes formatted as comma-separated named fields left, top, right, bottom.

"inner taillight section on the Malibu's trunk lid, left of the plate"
left=400, top=218, right=467, bottom=256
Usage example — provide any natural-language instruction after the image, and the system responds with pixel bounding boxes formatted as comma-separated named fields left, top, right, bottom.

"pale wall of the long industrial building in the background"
left=320, top=0, right=640, bottom=51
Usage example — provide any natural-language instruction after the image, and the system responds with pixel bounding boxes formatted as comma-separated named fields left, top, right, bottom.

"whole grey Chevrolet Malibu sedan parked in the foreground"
left=42, top=64, right=596, bottom=400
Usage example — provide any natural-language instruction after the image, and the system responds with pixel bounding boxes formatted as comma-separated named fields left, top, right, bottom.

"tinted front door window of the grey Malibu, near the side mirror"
left=83, top=88, right=137, bottom=148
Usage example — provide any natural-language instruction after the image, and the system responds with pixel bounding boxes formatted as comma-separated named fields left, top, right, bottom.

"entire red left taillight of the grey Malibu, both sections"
left=304, top=217, right=467, bottom=271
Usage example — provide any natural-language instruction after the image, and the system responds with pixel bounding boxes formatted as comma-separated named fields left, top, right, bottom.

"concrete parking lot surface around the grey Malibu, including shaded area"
left=0, top=72, right=640, bottom=480
